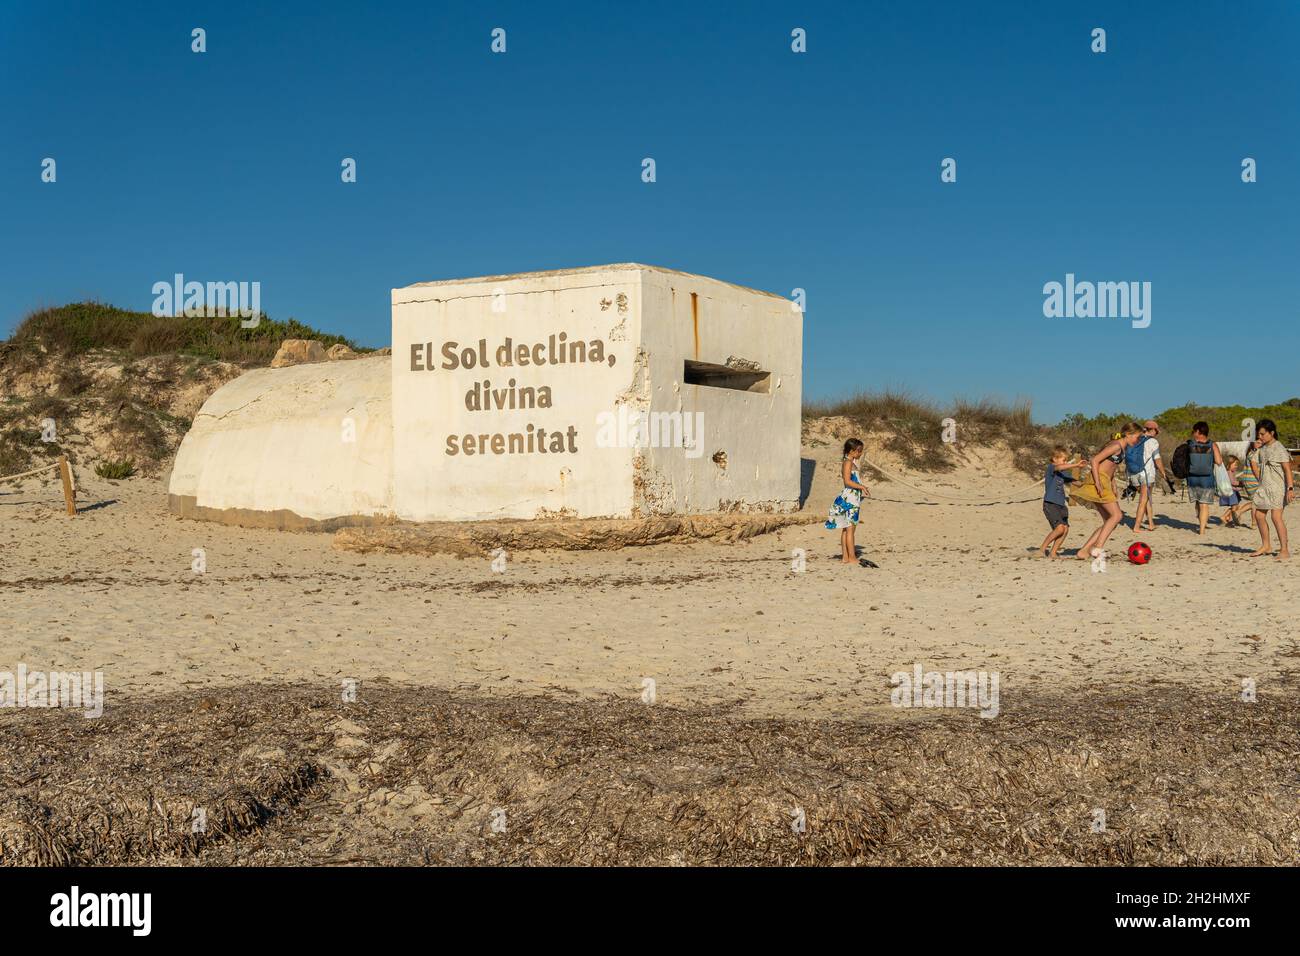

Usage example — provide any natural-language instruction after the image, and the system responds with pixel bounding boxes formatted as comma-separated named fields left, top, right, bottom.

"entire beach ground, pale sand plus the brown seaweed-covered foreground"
left=0, top=434, right=1300, bottom=865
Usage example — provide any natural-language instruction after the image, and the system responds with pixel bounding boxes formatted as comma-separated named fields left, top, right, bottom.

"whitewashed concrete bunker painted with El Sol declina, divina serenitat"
left=169, top=264, right=802, bottom=529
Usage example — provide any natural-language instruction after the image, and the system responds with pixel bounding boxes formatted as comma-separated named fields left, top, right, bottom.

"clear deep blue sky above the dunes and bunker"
left=0, top=0, right=1300, bottom=420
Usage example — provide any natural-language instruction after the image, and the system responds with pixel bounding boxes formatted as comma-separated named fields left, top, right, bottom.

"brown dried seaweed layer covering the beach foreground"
left=0, top=685, right=1300, bottom=865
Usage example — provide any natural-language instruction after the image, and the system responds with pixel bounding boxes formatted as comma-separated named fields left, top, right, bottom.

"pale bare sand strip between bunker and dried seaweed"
left=0, top=431, right=1300, bottom=718
